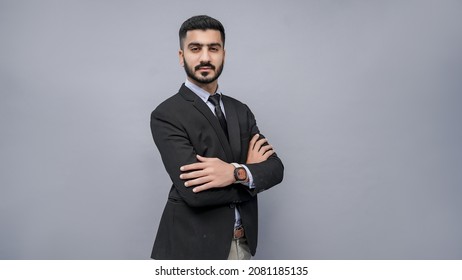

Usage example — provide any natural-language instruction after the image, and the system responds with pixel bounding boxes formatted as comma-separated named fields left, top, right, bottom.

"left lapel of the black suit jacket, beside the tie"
left=179, top=84, right=233, bottom=161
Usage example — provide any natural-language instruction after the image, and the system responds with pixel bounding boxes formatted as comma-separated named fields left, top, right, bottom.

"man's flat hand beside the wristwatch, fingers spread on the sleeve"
left=180, top=155, right=235, bottom=193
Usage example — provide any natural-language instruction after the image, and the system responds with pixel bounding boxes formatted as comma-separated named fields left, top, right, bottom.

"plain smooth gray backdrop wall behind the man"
left=0, top=0, right=462, bottom=259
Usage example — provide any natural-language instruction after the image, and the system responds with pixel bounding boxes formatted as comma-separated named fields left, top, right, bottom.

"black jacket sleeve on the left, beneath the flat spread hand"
left=151, top=108, right=252, bottom=207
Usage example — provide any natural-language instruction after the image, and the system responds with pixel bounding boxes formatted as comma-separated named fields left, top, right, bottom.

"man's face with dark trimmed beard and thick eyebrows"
left=179, top=29, right=225, bottom=84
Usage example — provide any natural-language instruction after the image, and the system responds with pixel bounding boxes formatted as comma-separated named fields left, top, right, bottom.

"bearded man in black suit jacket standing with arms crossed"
left=151, top=16, right=284, bottom=259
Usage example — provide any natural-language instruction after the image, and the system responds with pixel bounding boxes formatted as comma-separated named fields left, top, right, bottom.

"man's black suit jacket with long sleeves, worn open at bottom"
left=151, top=84, right=284, bottom=259
